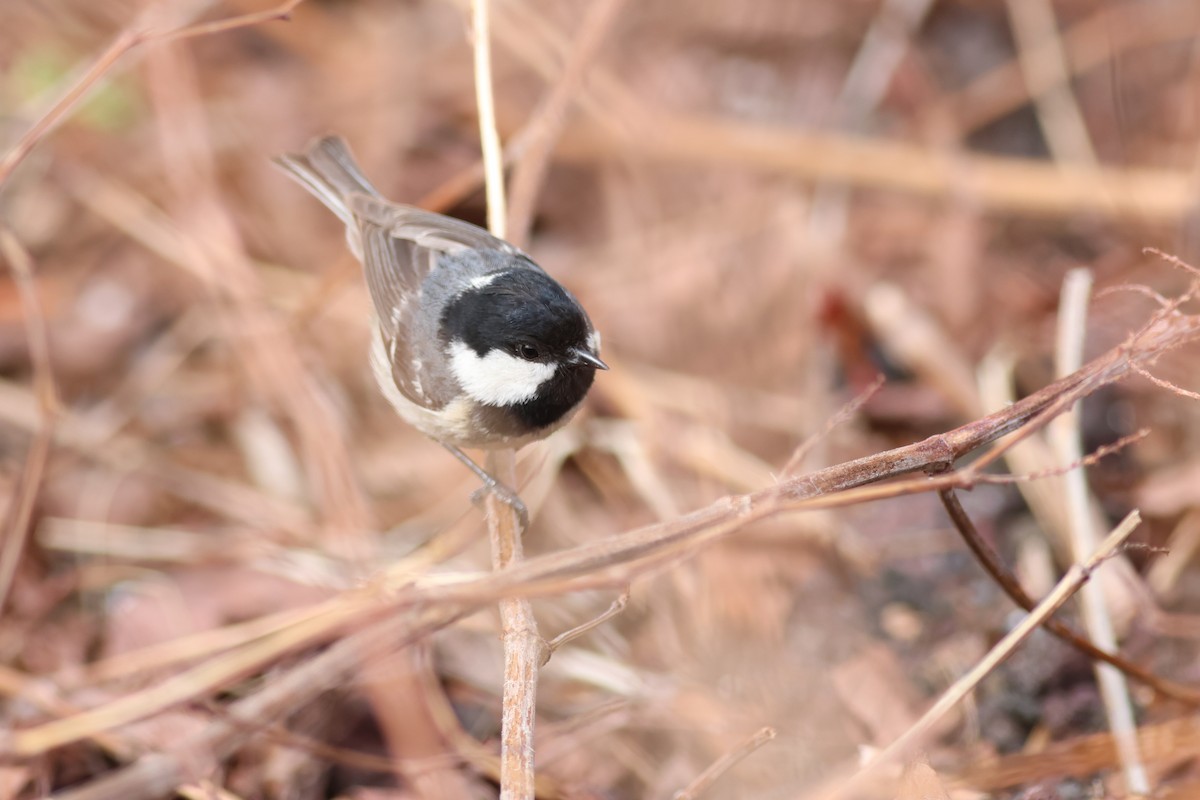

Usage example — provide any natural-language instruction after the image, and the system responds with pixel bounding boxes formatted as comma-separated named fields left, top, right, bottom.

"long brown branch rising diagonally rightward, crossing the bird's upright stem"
left=9, top=277, right=1200, bottom=777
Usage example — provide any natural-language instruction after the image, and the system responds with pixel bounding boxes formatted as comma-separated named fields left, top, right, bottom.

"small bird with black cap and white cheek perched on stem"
left=274, top=136, right=608, bottom=527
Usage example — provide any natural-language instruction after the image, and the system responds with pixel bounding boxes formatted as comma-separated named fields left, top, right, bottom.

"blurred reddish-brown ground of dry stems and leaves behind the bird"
left=0, top=0, right=1200, bottom=799
